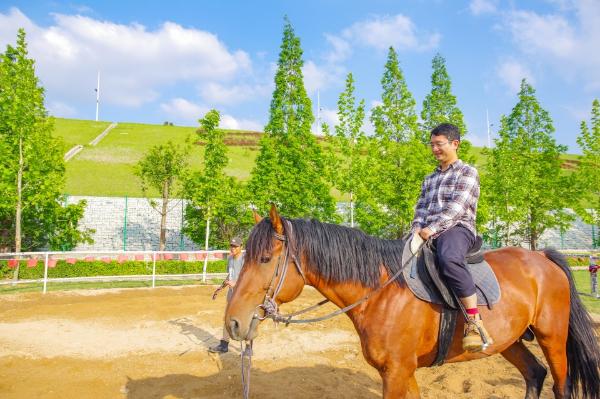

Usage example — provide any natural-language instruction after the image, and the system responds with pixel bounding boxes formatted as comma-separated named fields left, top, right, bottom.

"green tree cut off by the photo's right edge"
left=575, top=99, right=600, bottom=246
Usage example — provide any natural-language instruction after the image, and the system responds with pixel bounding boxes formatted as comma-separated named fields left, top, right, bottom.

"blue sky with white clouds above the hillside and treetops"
left=0, top=0, right=600, bottom=153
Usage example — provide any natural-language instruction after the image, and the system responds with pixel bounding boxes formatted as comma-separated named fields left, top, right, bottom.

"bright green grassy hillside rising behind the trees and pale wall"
left=55, top=118, right=578, bottom=199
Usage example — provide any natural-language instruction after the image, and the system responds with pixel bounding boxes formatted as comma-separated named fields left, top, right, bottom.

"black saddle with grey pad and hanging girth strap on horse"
left=402, top=237, right=501, bottom=366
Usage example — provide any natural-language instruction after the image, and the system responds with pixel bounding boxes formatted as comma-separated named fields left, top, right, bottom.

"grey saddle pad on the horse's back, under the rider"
left=402, top=240, right=501, bottom=306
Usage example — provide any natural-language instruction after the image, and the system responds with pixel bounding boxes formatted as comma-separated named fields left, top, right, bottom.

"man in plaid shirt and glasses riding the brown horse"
left=411, top=123, right=492, bottom=352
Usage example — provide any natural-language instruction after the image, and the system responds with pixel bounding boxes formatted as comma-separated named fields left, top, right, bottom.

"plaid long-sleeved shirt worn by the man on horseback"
left=412, top=159, right=479, bottom=237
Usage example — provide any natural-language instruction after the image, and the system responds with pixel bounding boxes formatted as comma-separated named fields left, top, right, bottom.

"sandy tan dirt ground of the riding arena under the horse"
left=0, top=286, right=596, bottom=399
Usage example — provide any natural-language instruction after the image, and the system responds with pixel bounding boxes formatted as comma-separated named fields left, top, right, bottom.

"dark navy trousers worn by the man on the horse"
left=434, top=225, right=475, bottom=298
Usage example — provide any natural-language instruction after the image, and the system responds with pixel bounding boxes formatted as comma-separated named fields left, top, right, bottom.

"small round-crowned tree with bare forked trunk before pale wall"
left=135, top=141, right=188, bottom=251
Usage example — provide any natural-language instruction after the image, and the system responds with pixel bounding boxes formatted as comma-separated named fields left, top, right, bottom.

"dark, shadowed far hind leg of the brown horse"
left=501, top=341, right=548, bottom=399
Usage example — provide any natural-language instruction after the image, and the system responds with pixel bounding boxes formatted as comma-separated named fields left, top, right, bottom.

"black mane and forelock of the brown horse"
left=246, top=218, right=404, bottom=287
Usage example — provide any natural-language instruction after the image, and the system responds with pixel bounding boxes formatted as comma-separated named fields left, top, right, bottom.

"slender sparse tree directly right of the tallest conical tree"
left=324, top=73, right=365, bottom=227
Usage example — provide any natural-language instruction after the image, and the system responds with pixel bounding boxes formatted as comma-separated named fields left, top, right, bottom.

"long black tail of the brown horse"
left=544, top=249, right=600, bottom=399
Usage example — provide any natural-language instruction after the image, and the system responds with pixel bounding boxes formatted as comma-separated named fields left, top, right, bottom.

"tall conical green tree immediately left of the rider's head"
left=357, top=47, right=433, bottom=238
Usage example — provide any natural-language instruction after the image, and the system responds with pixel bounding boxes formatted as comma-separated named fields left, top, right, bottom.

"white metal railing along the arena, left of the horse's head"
left=0, top=250, right=229, bottom=294
